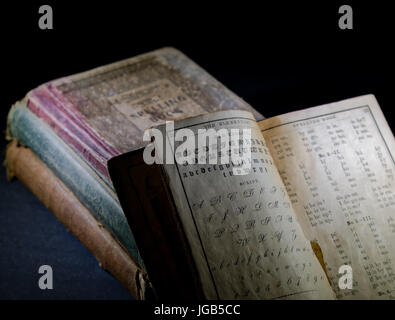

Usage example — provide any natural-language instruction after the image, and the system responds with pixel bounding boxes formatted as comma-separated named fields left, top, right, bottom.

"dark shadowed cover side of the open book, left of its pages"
left=108, top=149, right=204, bottom=300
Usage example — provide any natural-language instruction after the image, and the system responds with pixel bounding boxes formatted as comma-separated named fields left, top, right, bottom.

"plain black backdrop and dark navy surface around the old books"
left=0, top=1, right=395, bottom=299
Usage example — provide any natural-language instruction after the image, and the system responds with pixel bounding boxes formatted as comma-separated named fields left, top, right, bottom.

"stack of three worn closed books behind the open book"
left=6, top=48, right=262, bottom=299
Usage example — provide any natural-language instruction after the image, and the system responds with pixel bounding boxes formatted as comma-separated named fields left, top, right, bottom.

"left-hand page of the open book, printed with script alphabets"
left=155, top=111, right=334, bottom=299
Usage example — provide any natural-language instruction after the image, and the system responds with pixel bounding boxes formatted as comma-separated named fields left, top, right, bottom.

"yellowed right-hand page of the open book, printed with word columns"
left=259, top=95, right=395, bottom=299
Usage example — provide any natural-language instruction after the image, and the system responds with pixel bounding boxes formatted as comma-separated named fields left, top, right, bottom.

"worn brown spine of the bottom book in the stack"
left=6, top=140, right=152, bottom=299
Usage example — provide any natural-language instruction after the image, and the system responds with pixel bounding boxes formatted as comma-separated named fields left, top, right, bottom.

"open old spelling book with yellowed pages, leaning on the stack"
left=109, top=95, right=395, bottom=299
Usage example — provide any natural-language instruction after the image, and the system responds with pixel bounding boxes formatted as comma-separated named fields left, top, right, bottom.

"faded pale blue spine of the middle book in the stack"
left=7, top=101, right=143, bottom=266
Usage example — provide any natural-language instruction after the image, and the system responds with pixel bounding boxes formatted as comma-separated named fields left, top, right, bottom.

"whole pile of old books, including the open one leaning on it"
left=6, top=48, right=395, bottom=299
